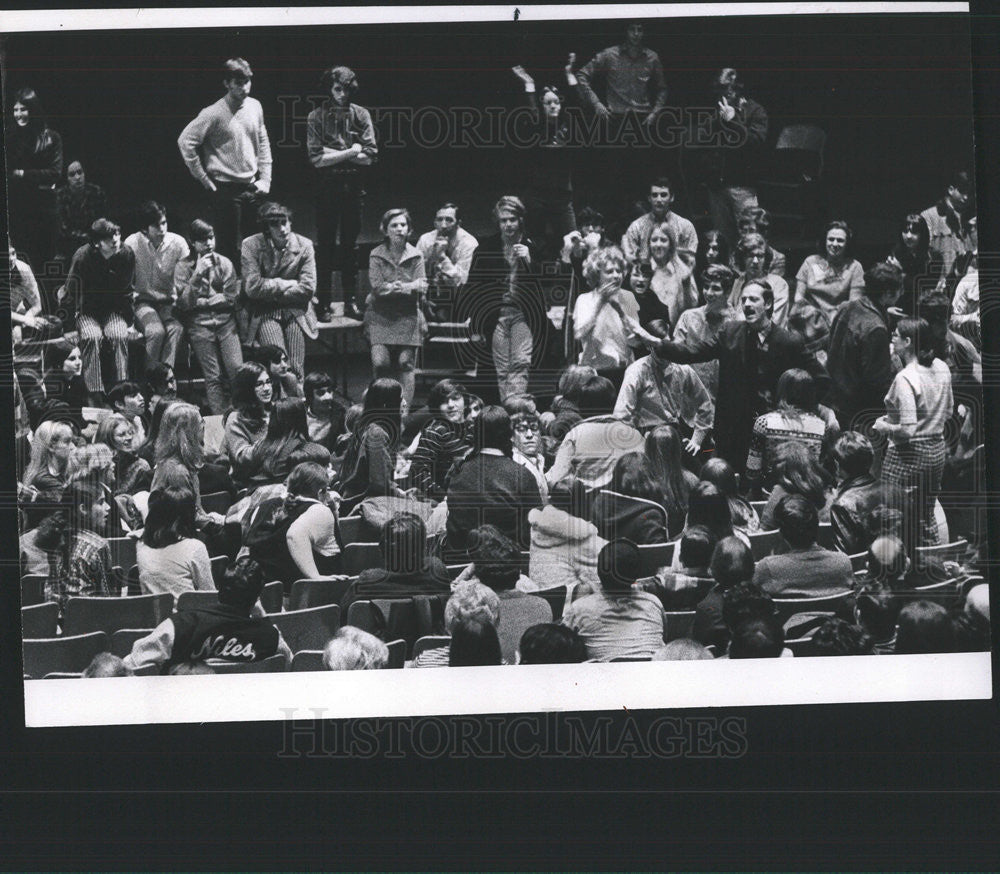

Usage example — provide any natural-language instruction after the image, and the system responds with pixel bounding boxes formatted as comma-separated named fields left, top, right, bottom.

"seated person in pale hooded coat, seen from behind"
left=522, top=480, right=606, bottom=598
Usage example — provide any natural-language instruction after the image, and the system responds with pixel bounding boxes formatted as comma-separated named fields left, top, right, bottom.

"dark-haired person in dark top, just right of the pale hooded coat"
left=590, top=452, right=669, bottom=543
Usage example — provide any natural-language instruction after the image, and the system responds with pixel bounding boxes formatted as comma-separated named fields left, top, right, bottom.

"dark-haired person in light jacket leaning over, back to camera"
left=545, top=376, right=645, bottom=491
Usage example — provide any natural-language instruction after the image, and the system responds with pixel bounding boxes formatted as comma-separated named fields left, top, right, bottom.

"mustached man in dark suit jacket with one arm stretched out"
left=660, top=279, right=828, bottom=472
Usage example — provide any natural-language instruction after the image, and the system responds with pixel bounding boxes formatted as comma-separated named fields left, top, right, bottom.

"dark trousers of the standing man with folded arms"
left=316, top=173, right=365, bottom=309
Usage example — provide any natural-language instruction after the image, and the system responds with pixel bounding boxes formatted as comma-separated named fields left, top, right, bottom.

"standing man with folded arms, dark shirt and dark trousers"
left=306, top=67, right=378, bottom=322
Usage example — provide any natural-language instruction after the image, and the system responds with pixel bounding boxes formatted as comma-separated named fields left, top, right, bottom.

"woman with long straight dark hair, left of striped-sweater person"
left=340, top=379, right=406, bottom=516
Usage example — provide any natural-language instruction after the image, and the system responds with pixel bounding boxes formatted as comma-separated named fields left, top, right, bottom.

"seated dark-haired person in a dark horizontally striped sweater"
left=410, top=379, right=472, bottom=501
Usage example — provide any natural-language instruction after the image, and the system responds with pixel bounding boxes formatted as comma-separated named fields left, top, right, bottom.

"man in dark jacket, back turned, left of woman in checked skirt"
left=826, top=261, right=903, bottom=430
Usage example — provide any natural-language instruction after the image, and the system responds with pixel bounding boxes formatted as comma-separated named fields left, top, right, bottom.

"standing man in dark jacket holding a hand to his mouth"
left=708, top=67, right=767, bottom=246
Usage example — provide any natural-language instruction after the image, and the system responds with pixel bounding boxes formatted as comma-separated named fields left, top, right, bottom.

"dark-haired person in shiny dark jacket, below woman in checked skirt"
left=830, top=431, right=901, bottom=555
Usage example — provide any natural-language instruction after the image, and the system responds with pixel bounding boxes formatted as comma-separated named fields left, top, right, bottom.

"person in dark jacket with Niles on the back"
left=125, top=558, right=292, bottom=671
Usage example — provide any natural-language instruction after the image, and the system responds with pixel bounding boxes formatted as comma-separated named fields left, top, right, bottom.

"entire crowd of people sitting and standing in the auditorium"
left=7, top=31, right=989, bottom=676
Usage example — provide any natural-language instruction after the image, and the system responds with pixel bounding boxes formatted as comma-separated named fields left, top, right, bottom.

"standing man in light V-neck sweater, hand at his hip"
left=177, top=58, right=271, bottom=260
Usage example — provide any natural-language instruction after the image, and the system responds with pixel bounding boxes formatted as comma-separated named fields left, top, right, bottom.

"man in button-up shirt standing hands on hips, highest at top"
left=576, top=21, right=667, bottom=215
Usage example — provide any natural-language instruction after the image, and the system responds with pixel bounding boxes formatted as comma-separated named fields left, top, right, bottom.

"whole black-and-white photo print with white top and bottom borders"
left=3, top=3, right=995, bottom=727
